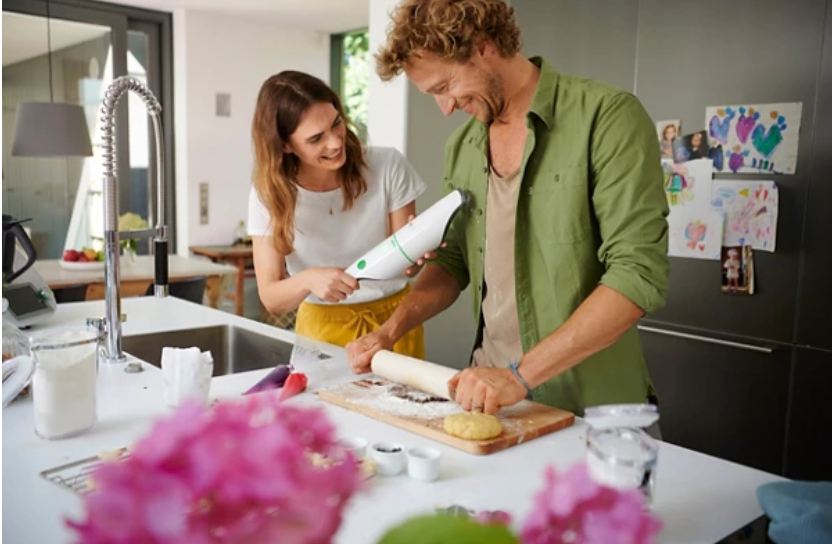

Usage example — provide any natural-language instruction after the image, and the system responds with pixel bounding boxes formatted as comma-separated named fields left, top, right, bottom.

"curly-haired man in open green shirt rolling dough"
left=347, top=0, right=669, bottom=414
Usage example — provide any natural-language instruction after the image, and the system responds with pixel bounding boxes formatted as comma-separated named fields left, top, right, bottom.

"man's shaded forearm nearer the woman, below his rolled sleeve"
left=382, top=265, right=461, bottom=341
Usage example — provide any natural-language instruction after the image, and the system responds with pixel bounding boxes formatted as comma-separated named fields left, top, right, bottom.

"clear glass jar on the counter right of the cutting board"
left=584, top=404, right=659, bottom=509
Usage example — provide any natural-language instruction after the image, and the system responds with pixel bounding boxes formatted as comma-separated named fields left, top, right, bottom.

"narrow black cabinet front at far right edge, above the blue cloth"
left=786, top=348, right=832, bottom=480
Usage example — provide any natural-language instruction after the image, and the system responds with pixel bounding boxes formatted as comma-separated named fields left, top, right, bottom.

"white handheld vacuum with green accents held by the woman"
left=346, top=189, right=466, bottom=280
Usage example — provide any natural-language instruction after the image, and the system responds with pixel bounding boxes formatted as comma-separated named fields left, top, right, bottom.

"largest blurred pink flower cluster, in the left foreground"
left=67, top=395, right=361, bottom=544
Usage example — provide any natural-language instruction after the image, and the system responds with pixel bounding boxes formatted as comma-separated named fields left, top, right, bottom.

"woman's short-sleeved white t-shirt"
left=248, top=147, right=425, bottom=304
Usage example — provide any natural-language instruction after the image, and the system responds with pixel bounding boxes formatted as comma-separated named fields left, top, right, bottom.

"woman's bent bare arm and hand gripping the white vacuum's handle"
left=251, top=236, right=358, bottom=314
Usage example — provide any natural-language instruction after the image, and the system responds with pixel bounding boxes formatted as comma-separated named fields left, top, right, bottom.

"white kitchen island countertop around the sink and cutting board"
left=2, top=297, right=781, bottom=544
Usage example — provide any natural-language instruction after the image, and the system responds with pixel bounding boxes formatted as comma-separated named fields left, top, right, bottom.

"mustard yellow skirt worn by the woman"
left=295, top=285, right=425, bottom=359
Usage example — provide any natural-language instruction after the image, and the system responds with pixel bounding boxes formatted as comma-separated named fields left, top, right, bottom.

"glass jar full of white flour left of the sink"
left=29, top=327, right=101, bottom=440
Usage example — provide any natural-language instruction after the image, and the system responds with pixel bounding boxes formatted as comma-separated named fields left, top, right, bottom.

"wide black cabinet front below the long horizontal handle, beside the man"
left=641, top=331, right=792, bottom=473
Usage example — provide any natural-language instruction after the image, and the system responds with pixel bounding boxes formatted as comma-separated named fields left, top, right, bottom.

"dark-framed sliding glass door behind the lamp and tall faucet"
left=3, top=0, right=174, bottom=258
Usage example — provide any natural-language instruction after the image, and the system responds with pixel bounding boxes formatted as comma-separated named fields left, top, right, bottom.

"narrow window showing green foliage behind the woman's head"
left=330, top=29, right=371, bottom=142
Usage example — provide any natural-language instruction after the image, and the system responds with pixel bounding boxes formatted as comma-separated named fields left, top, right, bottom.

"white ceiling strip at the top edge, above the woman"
left=107, top=0, right=370, bottom=33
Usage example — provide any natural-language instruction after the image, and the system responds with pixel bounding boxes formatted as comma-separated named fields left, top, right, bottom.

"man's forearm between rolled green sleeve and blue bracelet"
left=519, top=285, right=644, bottom=388
